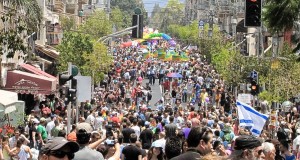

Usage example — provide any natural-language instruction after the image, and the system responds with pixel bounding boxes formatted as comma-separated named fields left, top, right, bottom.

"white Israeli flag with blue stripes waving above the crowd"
left=236, top=101, right=269, bottom=136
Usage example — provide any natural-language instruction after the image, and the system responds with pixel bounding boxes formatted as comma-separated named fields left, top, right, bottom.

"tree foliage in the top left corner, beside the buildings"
left=0, top=0, right=42, bottom=58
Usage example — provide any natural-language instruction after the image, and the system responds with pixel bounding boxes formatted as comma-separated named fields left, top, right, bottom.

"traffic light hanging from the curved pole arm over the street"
left=131, top=14, right=144, bottom=38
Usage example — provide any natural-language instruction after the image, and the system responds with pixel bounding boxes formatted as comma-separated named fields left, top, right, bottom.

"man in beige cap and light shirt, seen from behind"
left=74, top=122, right=104, bottom=160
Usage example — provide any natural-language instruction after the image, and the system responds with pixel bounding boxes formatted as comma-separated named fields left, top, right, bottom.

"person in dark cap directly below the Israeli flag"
left=229, top=135, right=264, bottom=160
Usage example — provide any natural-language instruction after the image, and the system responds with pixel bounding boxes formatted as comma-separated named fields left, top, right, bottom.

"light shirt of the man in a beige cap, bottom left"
left=73, top=146, right=104, bottom=160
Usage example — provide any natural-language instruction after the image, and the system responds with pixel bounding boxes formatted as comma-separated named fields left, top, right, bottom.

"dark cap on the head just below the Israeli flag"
left=234, top=135, right=261, bottom=150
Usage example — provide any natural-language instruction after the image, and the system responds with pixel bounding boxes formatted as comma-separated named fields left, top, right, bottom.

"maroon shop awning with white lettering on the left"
left=4, top=70, right=56, bottom=95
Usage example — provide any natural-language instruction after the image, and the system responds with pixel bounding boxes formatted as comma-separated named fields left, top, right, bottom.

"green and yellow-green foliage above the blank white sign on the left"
left=57, top=32, right=113, bottom=83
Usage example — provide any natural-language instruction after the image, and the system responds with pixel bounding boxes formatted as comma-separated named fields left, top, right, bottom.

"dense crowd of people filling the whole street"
left=0, top=43, right=300, bottom=160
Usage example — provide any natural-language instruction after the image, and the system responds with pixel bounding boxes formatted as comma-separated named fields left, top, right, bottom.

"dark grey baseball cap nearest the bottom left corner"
left=41, top=137, right=79, bottom=153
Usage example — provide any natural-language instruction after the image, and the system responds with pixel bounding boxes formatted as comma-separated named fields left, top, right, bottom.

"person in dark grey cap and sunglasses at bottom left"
left=39, top=137, right=79, bottom=160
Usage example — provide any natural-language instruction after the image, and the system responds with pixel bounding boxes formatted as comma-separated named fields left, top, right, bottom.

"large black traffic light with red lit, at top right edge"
left=245, top=0, right=262, bottom=27
